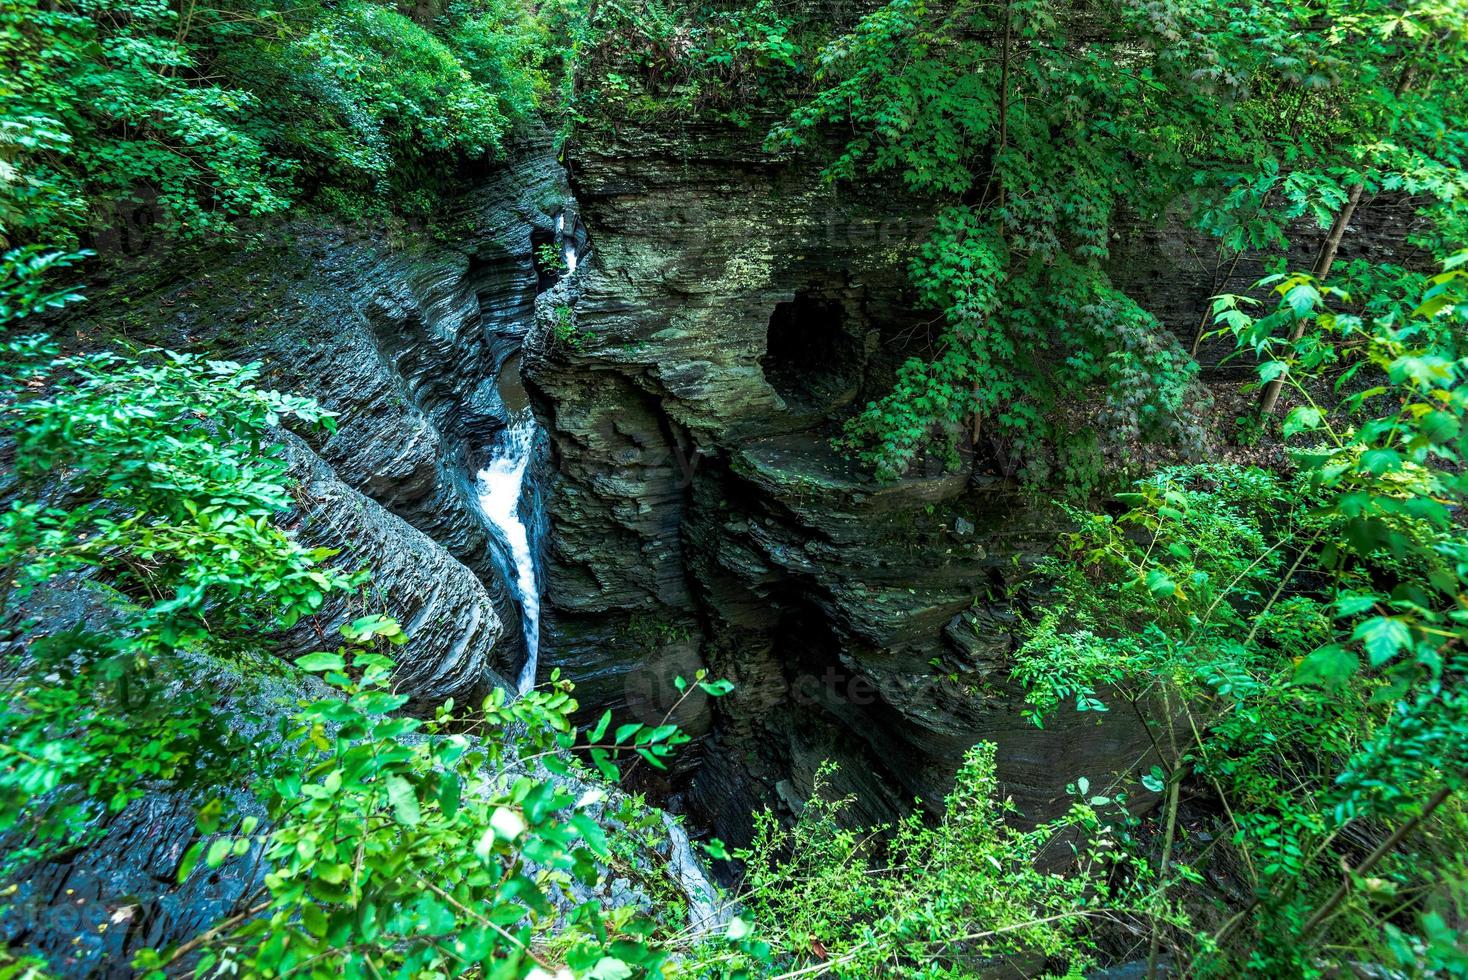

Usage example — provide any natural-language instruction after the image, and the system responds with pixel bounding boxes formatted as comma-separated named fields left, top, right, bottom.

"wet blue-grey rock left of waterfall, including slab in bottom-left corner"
left=0, top=142, right=578, bottom=976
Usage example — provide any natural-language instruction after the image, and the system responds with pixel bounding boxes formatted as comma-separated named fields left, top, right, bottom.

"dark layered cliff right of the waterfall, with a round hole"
left=526, top=123, right=1168, bottom=841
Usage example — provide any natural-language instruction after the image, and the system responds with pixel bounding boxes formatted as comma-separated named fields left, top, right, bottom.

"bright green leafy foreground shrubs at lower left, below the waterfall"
left=0, top=337, right=704, bottom=976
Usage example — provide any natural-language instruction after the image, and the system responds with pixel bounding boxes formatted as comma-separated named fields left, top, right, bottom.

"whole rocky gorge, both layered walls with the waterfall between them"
left=9, top=110, right=1432, bottom=957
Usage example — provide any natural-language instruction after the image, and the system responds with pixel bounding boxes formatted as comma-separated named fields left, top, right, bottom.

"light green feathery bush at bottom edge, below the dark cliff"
left=744, top=742, right=1176, bottom=977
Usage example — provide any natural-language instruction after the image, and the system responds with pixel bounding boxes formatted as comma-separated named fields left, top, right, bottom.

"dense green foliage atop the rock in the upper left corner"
left=0, top=0, right=542, bottom=248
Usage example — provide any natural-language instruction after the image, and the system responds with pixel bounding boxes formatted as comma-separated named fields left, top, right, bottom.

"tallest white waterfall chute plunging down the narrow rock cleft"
left=479, top=406, right=540, bottom=694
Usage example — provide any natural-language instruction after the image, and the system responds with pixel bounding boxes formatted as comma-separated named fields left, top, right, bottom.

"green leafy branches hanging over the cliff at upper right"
left=771, top=0, right=1468, bottom=486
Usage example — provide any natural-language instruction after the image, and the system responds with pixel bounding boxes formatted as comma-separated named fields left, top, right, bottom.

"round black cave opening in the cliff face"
left=760, top=292, right=863, bottom=412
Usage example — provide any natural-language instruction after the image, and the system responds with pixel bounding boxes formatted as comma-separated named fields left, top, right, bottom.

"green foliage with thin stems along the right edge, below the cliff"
left=1017, top=252, right=1468, bottom=976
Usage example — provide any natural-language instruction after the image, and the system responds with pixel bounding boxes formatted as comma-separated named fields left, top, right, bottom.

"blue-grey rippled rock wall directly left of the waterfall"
left=70, top=139, right=570, bottom=700
